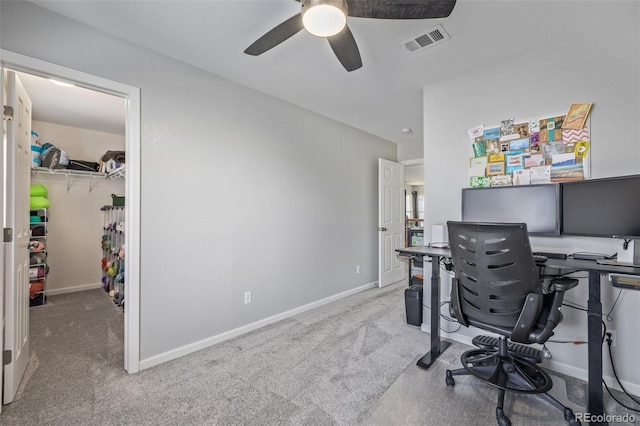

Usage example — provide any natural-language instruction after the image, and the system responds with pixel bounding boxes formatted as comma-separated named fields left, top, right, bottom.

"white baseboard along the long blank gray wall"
left=140, top=282, right=377, bottom=371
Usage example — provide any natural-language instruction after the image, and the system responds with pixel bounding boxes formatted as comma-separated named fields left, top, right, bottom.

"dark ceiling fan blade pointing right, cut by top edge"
left=347, top=0, right=456, bottom=19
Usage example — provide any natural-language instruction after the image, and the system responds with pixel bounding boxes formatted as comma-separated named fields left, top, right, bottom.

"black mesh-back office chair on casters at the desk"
left=446, top=222, right=580, bottom=426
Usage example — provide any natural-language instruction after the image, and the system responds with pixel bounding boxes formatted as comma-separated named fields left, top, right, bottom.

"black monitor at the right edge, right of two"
left=562, top=175, right=640, bottom=239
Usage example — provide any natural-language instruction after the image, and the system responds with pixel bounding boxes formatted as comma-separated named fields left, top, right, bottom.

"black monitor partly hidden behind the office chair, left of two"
left=462, top=184, right=560, bottom=236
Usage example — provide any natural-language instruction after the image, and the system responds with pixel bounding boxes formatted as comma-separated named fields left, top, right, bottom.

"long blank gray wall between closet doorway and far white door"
left=0, top=1, right=396, bottom=361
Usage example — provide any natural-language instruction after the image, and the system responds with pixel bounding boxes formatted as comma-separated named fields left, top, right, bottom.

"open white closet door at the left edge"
left=2, top=69, right=31, bottom=404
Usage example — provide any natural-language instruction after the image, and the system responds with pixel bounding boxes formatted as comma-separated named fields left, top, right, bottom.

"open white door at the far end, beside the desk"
left=378, top=158, right=405, bottom=287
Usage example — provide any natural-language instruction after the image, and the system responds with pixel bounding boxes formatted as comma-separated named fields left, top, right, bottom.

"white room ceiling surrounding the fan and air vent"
left=18, top=0, right=633, bottom=143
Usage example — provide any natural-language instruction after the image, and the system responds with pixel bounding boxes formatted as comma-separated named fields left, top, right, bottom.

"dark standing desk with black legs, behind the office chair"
left=396, top=247, right=640, bottom=424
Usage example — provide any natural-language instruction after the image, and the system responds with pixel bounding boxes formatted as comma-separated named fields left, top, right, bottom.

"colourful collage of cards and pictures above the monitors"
left=468, top=102, right=593, bottom=188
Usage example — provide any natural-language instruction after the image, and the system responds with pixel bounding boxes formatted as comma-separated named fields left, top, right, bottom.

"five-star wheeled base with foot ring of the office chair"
left=446, top=336, right=580, bottom=426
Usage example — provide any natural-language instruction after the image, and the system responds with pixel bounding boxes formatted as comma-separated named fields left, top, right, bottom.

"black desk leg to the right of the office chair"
left=587, top=271, right=606, bottom=424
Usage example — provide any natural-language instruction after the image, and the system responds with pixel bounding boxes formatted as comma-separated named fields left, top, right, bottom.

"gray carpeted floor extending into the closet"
left=0, top=284, right=640, bottom=425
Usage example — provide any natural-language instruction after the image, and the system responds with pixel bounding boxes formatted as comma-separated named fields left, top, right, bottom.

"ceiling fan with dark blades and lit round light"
left=244, top=0, right=456, bottom=71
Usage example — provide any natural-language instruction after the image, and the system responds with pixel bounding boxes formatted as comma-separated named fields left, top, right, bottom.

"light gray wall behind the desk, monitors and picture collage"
left=424, top=2, right=640, bottom=394
